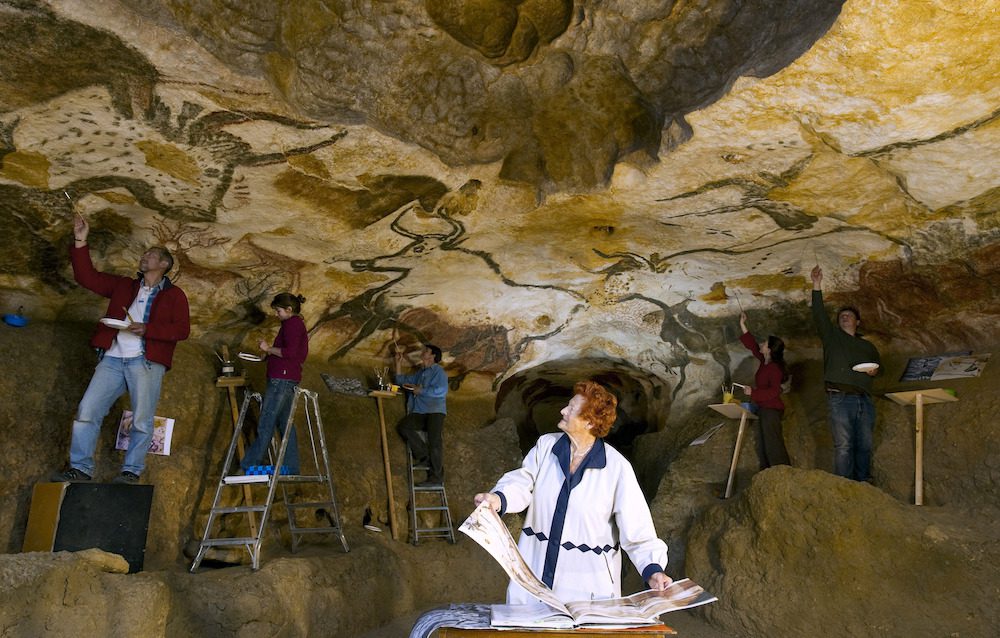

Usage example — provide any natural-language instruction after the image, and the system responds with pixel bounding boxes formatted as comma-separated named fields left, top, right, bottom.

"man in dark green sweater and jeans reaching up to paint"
left=811, top=266, right=881, bottom=481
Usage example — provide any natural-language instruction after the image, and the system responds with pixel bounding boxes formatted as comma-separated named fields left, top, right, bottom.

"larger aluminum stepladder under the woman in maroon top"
left=191, top=387, right=350, bottom=572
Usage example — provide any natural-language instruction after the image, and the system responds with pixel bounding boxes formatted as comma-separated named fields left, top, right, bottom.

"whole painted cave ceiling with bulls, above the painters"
left=0, top=0, right=1000, bottom=400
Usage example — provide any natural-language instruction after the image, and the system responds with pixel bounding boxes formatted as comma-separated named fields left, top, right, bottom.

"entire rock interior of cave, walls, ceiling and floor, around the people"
left=0, top=0, right=1000, bottom=638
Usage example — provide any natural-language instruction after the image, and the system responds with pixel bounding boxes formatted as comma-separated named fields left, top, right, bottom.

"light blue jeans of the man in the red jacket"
left=69, top=356, right=167, bottom=476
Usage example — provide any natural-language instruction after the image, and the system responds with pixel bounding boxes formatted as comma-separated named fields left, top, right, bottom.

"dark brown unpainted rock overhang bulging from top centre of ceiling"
left=119, top=0, right=843, bottom=193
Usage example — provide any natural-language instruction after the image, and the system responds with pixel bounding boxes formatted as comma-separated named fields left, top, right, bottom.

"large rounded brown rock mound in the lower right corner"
left=687, top=467, right=1000, bottom=637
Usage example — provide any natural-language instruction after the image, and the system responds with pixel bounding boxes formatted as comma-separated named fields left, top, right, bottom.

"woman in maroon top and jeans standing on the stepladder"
left=240, top=292, right=309, bottom=474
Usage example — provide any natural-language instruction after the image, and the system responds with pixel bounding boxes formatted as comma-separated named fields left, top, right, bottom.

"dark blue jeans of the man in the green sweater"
left=827, top=392, right=875, bottom=481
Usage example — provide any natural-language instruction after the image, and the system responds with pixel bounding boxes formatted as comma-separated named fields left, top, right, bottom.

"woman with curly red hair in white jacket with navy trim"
left=474, top=381, right=671, bottom=604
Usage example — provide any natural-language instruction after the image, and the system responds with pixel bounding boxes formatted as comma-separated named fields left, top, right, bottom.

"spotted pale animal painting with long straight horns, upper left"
left=0, top=84, right=346, bottom=222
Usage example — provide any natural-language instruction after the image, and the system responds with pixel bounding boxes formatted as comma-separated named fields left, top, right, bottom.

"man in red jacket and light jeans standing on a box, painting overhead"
left=52, top=215, right=190, bottom=483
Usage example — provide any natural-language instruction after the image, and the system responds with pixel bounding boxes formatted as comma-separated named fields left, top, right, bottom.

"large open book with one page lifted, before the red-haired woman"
left=459, top=501, right=717, bottom=629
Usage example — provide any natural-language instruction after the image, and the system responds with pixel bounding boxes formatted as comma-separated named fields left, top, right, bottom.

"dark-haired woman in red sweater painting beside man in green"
left=740, top=312, right=790, bottom=470
